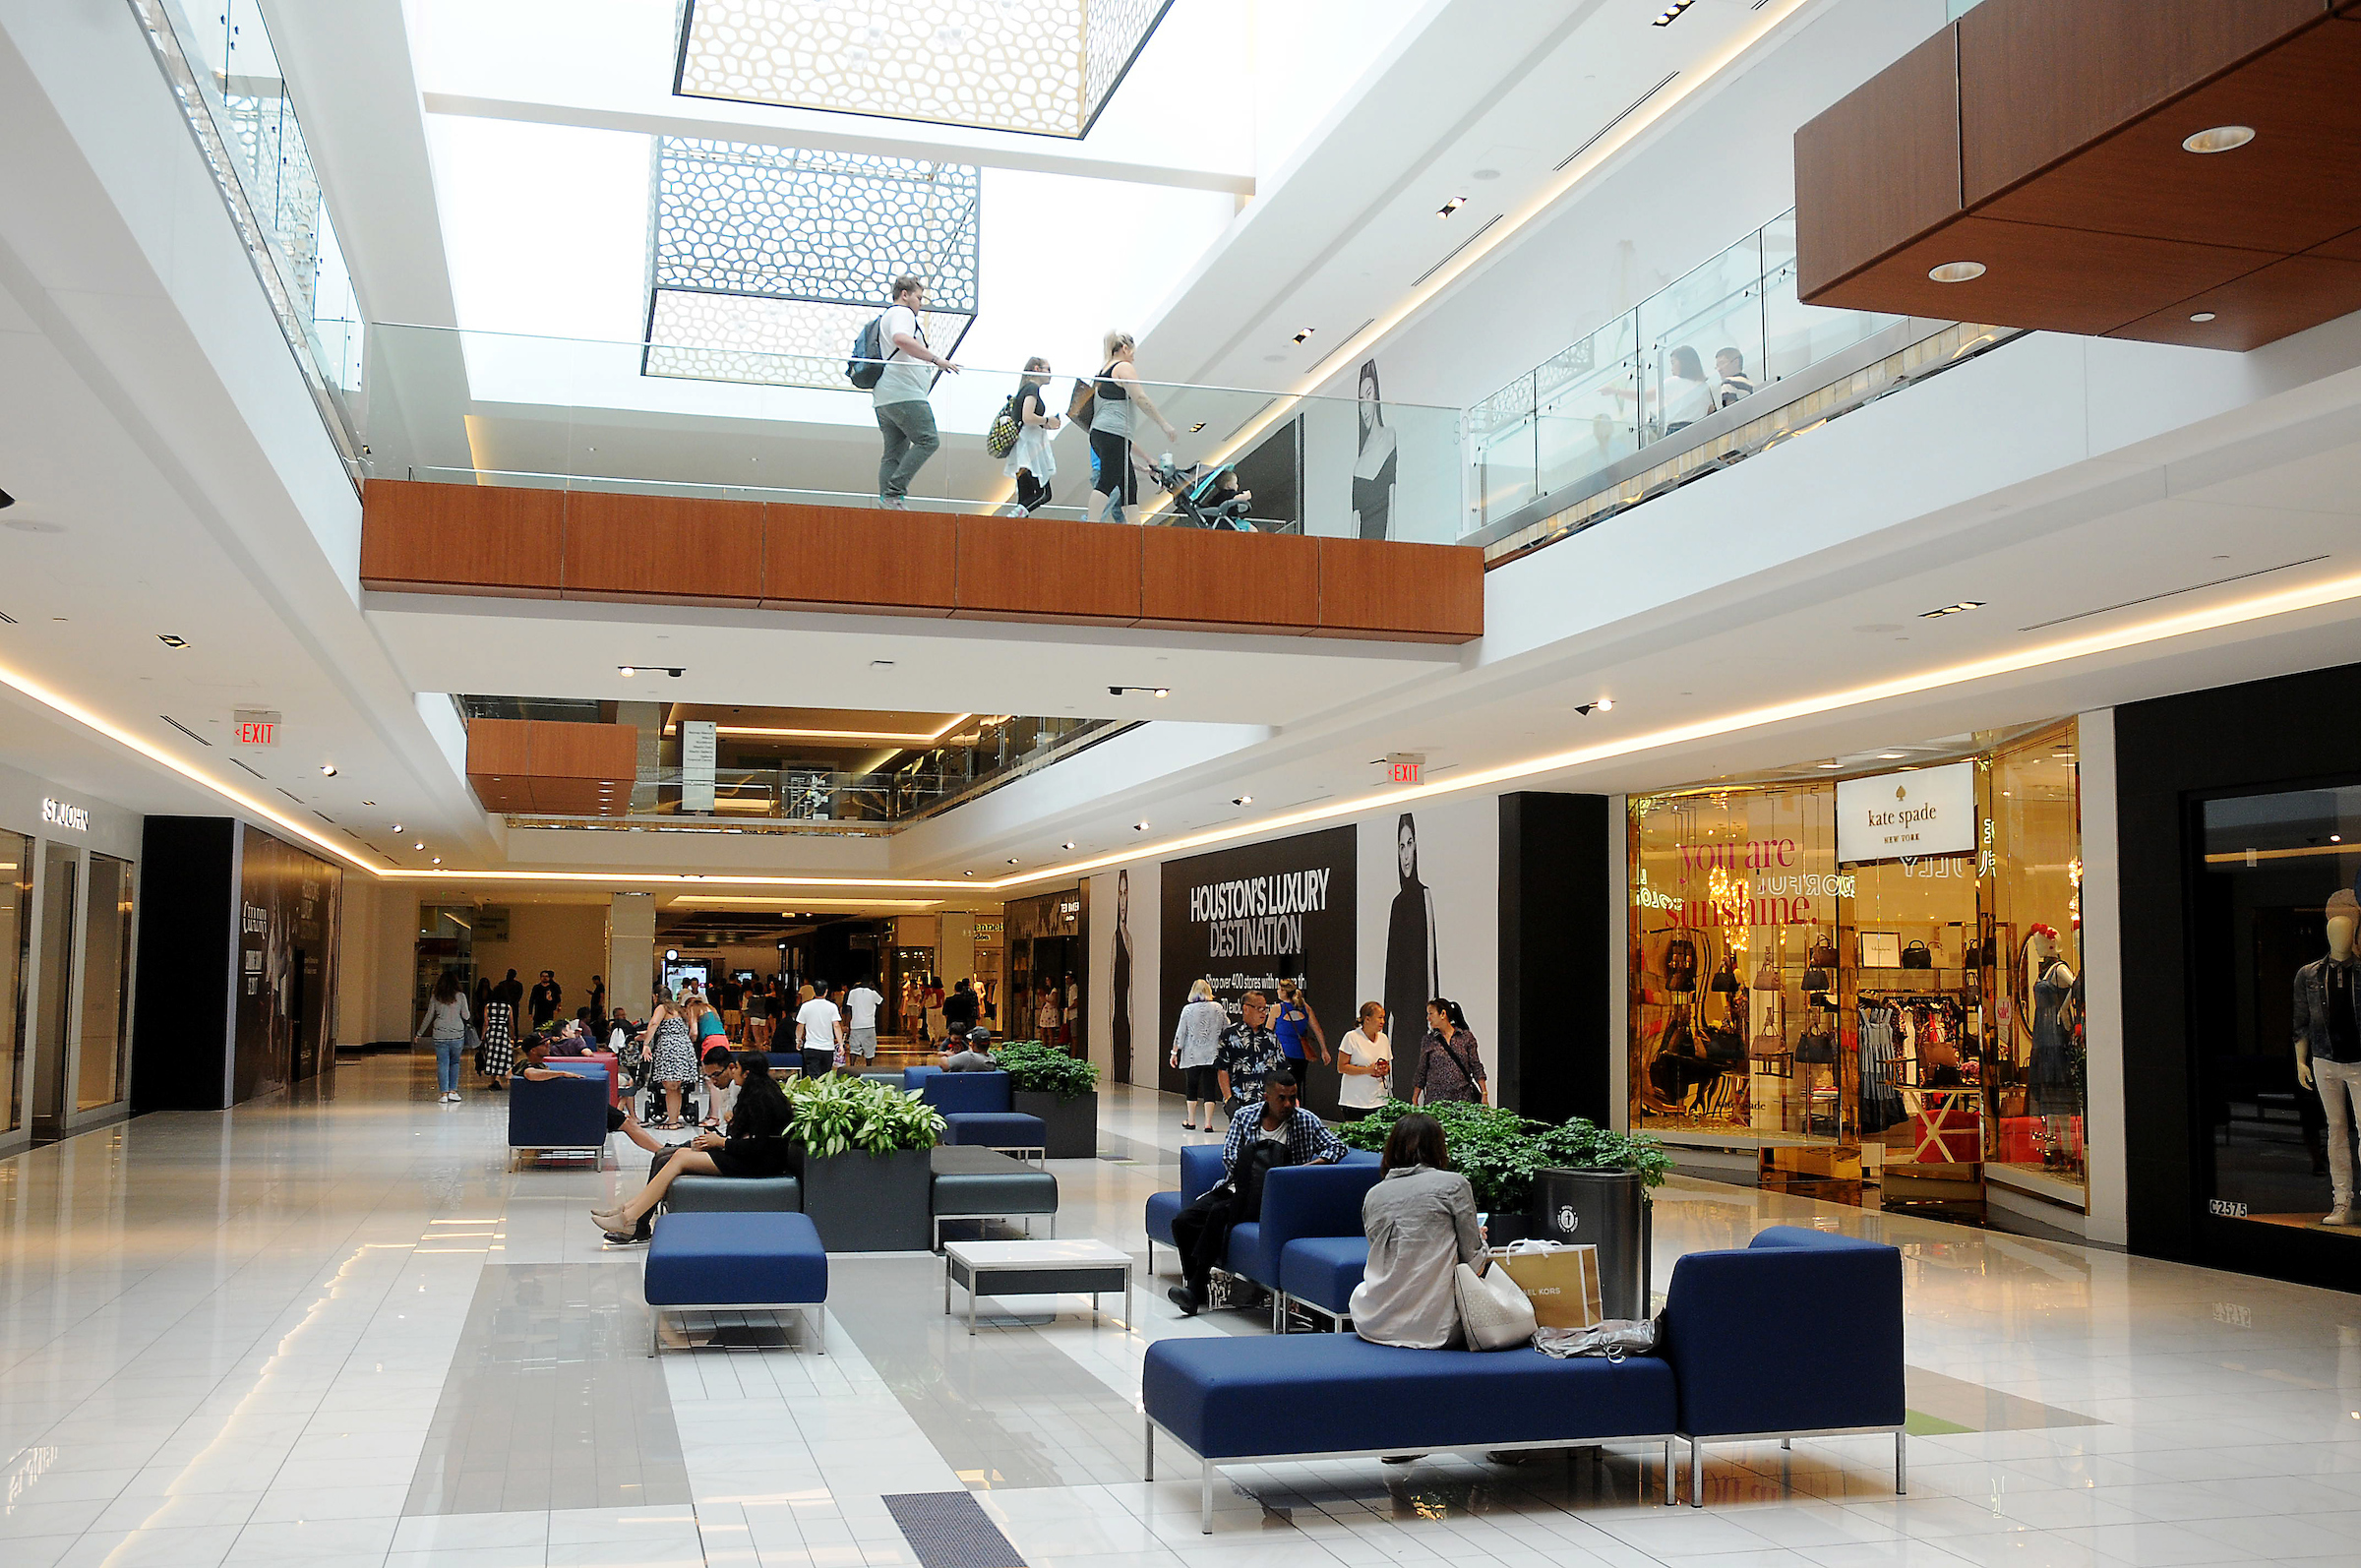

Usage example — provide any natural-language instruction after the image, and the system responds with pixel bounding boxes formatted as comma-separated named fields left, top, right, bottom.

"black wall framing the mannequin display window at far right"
left=2115, top=666, right=2361, bottom=1290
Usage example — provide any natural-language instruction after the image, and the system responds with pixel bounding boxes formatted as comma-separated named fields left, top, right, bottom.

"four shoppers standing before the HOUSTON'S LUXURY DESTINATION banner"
left=1167, top=980, right=1489, bottom=1131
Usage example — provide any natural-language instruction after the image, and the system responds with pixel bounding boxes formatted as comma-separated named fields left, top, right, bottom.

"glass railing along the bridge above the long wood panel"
left=347, top=324, right=1464, bottom=543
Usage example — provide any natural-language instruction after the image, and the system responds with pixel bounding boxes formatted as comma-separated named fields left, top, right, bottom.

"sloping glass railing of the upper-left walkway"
left=130, top=0, right=361, bottom=452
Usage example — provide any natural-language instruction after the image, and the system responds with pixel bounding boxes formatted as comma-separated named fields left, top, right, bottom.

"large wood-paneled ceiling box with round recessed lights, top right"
left=1794, top=0, right=2361, bottom=349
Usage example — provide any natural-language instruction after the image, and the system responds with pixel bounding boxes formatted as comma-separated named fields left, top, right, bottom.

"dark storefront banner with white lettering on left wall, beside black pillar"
left=231, top=826, right=342, bottom=1101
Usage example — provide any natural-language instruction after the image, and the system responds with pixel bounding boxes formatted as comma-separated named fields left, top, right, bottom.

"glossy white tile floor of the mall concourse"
left=0, top=1057, right=2361, bottom=1568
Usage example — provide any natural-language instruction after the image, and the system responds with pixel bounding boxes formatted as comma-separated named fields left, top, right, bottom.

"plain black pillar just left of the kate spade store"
left=1497, top=791, right=1615, bottom=1126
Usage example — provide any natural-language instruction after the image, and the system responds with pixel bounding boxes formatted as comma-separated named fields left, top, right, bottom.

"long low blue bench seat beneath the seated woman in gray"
left=1140, top=1334, right=1678, bottom=1531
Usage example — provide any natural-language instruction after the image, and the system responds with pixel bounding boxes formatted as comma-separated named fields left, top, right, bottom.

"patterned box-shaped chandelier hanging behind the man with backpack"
left=639, top=137, right=982, bottom=390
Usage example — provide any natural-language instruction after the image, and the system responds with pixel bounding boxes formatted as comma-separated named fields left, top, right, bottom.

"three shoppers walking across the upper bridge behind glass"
left=869, top=273, right=1180, bottom=522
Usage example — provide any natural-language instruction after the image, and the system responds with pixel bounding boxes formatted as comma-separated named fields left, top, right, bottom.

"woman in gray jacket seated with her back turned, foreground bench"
left=1351, top=1113, right=1485, bottom=1351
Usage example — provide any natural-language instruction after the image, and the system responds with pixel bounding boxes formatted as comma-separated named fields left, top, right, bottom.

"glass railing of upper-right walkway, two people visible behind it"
left=1464, top=211, right=1901, bottom=531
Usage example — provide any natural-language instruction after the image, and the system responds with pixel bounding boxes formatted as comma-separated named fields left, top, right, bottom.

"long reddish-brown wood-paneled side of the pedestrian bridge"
left=361, top=479, right=1483, bottom=641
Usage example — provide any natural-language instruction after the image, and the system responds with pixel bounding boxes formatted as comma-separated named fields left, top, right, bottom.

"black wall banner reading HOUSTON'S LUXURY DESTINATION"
left=1155, top=826, right=1360, bottom=1116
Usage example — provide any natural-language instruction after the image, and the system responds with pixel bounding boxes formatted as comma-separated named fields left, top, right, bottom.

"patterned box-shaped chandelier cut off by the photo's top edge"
left=673, top=0, right=1171, bottom=137
